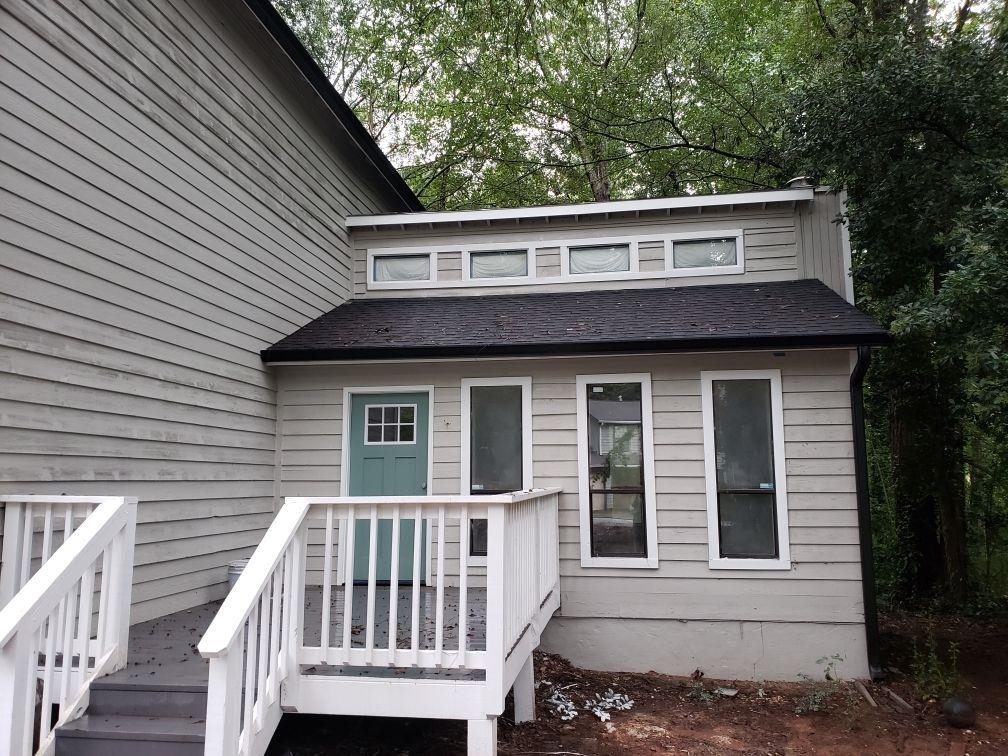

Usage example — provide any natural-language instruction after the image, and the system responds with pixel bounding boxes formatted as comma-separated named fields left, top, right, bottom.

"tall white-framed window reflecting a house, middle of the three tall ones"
left=577, top=373, right=658, bottom=569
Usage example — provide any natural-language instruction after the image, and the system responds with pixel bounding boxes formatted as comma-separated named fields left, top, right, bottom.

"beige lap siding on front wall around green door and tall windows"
left=278, top=350, right=863, bottom=623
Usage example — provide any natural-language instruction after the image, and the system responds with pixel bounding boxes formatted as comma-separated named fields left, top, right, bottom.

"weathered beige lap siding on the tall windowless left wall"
left=0, top=0, right=405, bottom=621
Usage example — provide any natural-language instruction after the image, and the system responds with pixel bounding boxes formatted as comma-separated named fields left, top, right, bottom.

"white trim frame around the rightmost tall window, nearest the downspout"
left=700, top=370, right=791, bottom=570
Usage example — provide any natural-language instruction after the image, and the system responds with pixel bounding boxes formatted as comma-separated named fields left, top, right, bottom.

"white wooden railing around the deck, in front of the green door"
left=199, top=489, right=559, bottom=756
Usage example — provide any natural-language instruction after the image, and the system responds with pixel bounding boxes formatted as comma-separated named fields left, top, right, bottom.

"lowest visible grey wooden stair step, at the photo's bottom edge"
left=55, top=713, right=206, bottom=756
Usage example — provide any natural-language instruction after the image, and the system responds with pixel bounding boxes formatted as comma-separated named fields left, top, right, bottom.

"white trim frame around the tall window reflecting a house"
left=575, top=373, right=658, bottom=570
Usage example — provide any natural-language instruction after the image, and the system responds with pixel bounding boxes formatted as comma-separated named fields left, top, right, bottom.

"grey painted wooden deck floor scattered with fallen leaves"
left=107, top=586, right=487, bottom=689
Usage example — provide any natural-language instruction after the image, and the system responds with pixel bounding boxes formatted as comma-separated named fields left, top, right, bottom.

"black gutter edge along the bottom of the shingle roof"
left=260, top=332, right=892, bottom=365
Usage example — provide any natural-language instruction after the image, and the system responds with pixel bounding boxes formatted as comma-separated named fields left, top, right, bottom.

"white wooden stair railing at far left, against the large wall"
left=0, top=496, right=136, bottom=756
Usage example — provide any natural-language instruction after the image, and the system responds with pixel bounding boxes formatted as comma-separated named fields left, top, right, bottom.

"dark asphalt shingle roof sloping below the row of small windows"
left=262, top=280, right=888, bottom=362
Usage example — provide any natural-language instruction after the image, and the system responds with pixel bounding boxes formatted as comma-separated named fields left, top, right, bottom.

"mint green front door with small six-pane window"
left=350, top=392, right=430, bottom=583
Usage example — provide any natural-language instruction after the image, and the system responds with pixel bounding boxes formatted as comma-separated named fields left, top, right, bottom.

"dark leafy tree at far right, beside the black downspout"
left=791, top=11, right=1008, bottom=599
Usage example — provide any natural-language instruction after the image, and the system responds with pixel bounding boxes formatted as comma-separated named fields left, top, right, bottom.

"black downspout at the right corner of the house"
left=851, top=346, right=885, bottom=680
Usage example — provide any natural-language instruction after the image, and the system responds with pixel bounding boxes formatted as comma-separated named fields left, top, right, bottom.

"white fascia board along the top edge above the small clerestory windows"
left=345, top=186, right=815, bottom=229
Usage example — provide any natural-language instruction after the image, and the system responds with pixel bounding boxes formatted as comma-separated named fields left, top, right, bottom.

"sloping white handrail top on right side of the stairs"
left=197, top=497, right=309, bottom=659
